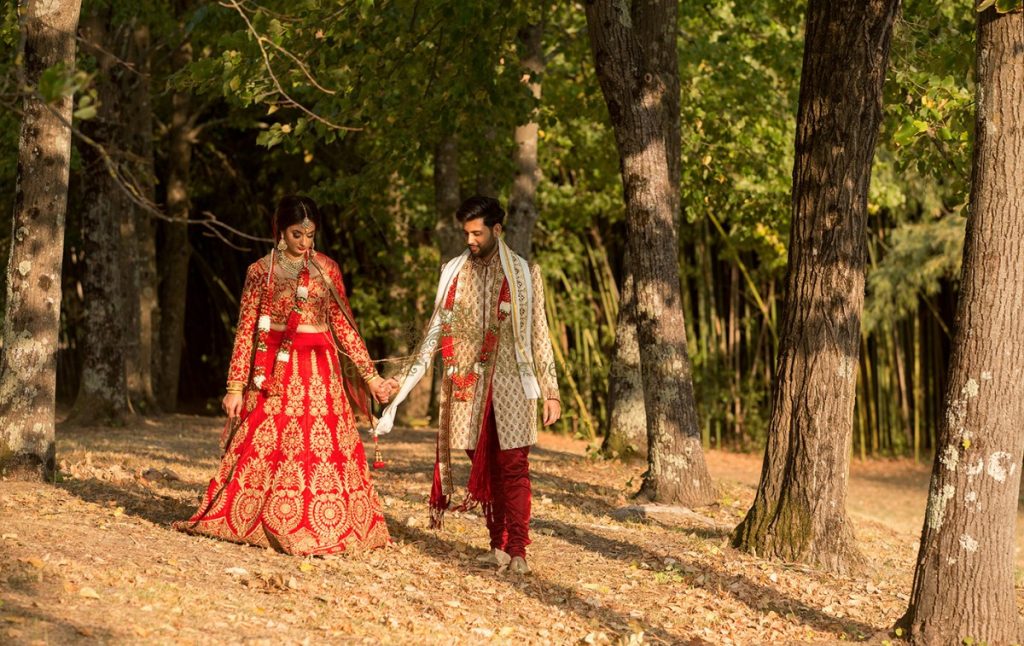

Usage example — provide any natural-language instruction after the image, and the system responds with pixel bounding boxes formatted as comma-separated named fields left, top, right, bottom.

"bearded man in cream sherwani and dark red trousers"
left=375, top=196, right=561, bottom=573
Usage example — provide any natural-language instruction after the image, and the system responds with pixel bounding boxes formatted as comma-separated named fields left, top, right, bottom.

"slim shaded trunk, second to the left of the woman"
left=122, top=17, right=160, bottom=412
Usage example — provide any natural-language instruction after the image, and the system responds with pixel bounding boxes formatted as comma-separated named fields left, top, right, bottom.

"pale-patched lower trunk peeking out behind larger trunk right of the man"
left=601, top=251, right=647, bottom=459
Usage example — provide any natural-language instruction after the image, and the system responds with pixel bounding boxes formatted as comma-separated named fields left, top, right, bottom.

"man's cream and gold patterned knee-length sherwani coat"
left=441, top=253, right=559, bottom=449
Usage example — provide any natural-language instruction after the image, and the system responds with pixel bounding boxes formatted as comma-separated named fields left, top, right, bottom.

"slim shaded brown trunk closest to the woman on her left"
left=157, top=42, right=193, bottom=413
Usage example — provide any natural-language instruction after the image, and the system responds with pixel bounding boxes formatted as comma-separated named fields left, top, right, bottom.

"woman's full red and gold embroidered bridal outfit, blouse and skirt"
left=174, top=254, right=390, bottom=555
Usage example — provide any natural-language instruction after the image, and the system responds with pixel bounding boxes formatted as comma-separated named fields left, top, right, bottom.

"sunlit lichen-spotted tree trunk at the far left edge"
left=0, top=0, right=81, bottom=479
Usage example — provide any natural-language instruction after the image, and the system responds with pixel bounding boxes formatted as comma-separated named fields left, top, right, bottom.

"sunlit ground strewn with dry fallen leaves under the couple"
left=0, top=416, right=1021, bottom=644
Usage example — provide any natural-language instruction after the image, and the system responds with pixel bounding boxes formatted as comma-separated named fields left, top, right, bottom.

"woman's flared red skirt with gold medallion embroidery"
left=174, top=332, right=390, bottom=555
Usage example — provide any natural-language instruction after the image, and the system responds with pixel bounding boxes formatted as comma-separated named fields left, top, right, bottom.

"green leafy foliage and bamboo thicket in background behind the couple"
left=0, top=0, right=975, bottom=460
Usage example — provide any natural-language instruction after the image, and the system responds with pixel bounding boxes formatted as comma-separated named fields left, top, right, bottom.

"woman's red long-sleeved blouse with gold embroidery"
left=227, top=253, right=377, bottom=384
